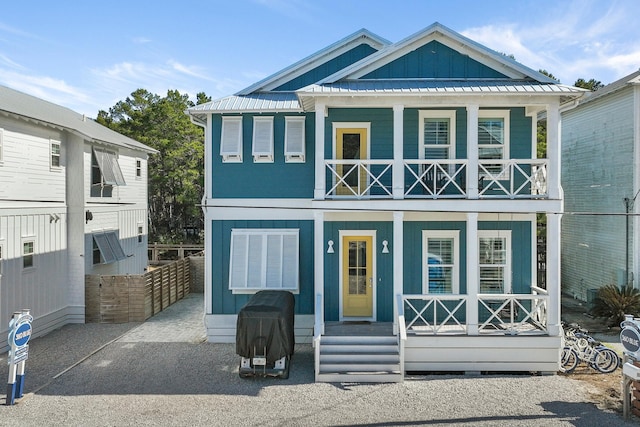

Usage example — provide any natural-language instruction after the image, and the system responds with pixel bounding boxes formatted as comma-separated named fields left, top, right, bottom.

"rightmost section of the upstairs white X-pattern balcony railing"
left=478, top=159, right=548, bottom=199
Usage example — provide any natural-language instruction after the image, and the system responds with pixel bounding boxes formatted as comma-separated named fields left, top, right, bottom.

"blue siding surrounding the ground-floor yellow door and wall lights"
left=324, top=221, right=393, bottom=322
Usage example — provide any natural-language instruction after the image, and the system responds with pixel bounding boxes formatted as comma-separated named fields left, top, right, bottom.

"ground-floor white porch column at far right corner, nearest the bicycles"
left=547, top=213, right=562, bottom=336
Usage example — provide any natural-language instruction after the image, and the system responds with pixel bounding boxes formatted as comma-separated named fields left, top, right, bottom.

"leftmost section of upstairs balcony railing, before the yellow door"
left=324, top=160, right=393, bottom=199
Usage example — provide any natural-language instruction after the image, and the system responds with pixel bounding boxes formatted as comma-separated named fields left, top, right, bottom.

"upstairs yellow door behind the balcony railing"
left=336, top=128, right=367, bottom=195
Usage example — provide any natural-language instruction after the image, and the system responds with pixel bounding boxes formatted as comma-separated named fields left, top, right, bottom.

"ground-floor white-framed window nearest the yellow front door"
left=422, top=230, right=460, bottom=294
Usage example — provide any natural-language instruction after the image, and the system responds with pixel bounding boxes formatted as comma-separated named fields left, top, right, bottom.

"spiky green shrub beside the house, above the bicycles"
left=591, top=285, right=640, bottom=326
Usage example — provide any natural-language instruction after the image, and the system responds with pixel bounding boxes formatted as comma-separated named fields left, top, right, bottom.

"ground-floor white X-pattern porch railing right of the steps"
left=403, top=287, right=549, bottom=335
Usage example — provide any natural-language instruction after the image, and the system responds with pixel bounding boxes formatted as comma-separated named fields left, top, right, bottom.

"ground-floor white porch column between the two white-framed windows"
left=467, top=212, right=480, bottom=335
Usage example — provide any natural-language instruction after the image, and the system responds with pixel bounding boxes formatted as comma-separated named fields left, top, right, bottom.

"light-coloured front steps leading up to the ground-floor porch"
left=316, top=335, right=404, bottom=383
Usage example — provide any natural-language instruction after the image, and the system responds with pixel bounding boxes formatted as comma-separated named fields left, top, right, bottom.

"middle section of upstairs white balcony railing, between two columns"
left=404, top=159, right=467, bottom=199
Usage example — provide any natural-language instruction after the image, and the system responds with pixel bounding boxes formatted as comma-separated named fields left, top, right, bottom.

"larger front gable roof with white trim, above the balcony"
left=317, top=22, right=558, bottom=85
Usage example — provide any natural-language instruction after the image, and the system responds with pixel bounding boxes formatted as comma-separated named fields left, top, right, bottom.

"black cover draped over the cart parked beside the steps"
left=236, top=291, right=295, bottom=363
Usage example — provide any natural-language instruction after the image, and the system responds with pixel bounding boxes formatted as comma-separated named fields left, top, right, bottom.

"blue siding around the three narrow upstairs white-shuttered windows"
left=211, top=113, right=315, bottom=199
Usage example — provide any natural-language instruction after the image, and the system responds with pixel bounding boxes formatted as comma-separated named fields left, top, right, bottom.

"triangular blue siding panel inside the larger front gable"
left=363, top=41, right=507, bottom=79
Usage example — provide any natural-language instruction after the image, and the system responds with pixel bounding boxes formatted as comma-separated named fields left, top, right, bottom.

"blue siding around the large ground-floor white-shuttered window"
left=211, top=220, right=313, bottom=314
